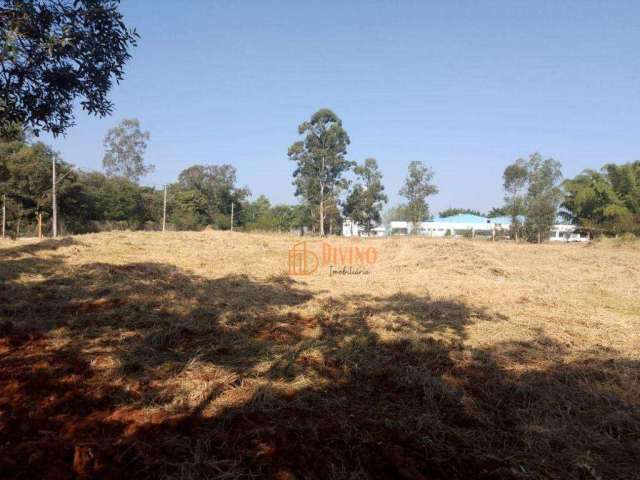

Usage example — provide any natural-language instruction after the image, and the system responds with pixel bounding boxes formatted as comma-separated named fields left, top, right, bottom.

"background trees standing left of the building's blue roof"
left=0, top=109, right=437, bottom=236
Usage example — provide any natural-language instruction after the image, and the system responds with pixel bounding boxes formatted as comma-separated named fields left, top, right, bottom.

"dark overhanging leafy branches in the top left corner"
left=0, top=0, right=138, bottom=136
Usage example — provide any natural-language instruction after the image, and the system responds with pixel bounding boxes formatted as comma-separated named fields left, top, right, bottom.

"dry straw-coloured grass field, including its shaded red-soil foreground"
left=0, top=232, right=640, bottom=480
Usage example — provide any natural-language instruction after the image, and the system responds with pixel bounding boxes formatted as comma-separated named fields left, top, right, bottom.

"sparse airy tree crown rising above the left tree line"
left=102, top=118, right=154, bottom=182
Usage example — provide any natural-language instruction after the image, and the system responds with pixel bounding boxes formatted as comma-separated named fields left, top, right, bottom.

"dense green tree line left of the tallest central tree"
left=0, top=119, right=307, bottom=236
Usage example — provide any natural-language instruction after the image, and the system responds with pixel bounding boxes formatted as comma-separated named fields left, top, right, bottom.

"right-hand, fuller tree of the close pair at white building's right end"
left=525, top=153, right=563, bottom=241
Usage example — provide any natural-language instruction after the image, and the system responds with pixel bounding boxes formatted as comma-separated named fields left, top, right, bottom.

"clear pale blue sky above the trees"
left=45, top=0, right=640, bottom=212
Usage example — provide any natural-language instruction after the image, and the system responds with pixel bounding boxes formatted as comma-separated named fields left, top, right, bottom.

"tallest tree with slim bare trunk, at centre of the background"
left=288, top=108, right=353, bottom=236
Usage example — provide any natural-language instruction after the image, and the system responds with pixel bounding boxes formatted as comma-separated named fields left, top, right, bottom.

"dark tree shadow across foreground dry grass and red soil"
left=0, top=242, right=640, bottom=479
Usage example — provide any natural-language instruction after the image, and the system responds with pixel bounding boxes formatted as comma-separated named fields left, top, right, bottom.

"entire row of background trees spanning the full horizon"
left=0, top=109, right=640, bottom=241
